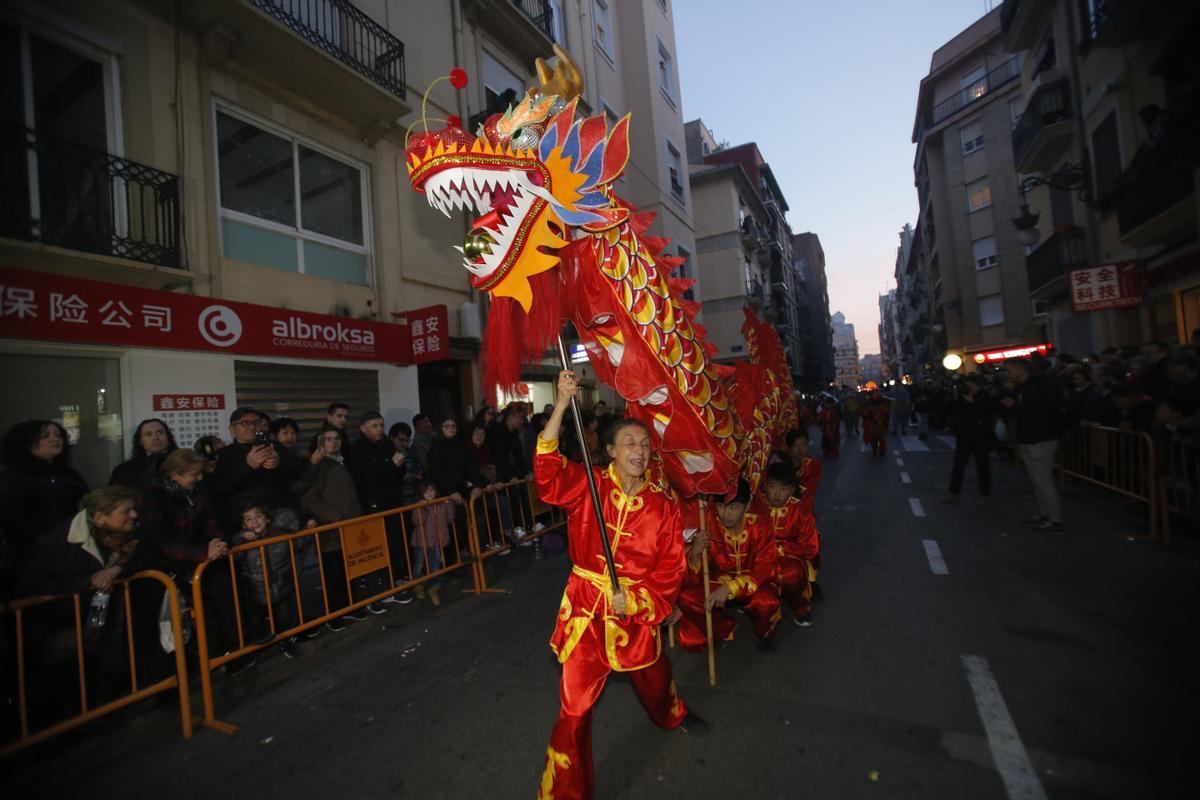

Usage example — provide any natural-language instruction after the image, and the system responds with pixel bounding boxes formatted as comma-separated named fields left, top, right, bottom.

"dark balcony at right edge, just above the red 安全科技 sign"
left=1115, top=149, right=1198, bottom=247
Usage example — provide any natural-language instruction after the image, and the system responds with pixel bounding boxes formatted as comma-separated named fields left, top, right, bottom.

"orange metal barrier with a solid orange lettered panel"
left=192, top=497, right=475, bottom=733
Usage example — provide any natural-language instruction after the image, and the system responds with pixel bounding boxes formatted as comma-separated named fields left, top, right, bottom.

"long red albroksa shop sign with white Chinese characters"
left=0, top=269, right=424, bottom=363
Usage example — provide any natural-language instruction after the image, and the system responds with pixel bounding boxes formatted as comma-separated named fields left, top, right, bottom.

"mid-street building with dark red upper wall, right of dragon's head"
left=685, top=120, right=808, bottom=385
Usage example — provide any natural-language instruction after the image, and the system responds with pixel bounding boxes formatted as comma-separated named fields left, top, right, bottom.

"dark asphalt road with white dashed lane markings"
left=0, top=437, right=1200, bottom=800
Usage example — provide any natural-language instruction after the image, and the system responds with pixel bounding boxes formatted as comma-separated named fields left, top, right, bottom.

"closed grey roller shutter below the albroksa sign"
left=234, top=361, right=379, bottom=446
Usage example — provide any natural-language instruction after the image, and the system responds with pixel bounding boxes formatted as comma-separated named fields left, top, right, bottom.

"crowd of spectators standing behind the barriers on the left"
left=0, top=402, right=612, bottom=710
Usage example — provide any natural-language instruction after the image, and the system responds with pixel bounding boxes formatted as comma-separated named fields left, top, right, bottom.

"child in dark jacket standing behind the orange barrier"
left=233, top=503, right=299, bottom=658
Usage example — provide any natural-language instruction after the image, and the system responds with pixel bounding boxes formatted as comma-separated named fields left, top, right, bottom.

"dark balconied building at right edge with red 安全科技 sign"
left=1001, top=0, right=1200, bottom=354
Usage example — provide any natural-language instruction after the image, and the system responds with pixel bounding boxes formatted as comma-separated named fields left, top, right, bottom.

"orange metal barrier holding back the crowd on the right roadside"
left=1056, top=426, right=1159, bottom=539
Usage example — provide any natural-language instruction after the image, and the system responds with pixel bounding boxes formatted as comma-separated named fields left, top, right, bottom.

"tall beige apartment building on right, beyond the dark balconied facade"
left=912, top=7, right=1040, bottom=361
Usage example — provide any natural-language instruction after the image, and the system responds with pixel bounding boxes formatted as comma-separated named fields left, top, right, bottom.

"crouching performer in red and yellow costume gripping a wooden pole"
left=678, top=479, right=779, bottom=651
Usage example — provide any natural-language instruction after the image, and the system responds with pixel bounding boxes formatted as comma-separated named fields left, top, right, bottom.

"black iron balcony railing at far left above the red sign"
left=0, top=127, right=181, bottom=267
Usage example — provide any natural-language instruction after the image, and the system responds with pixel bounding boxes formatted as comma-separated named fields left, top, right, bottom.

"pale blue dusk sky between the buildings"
left=671, top=0, right=998, bottom=354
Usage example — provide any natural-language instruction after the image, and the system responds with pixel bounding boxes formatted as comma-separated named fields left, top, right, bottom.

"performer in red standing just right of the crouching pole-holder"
left=750, top=459, right=816, bottom=627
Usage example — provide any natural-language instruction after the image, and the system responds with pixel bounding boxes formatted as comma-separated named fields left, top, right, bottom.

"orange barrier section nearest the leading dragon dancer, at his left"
left=470, top=479, right=566, bottom=591
